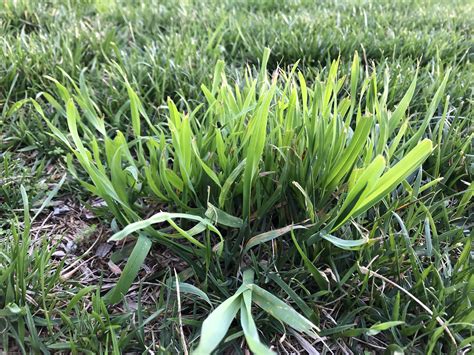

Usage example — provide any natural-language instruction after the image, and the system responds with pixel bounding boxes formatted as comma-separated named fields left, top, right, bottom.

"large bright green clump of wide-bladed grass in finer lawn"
left=14, top=51, right=464, bottom=351
